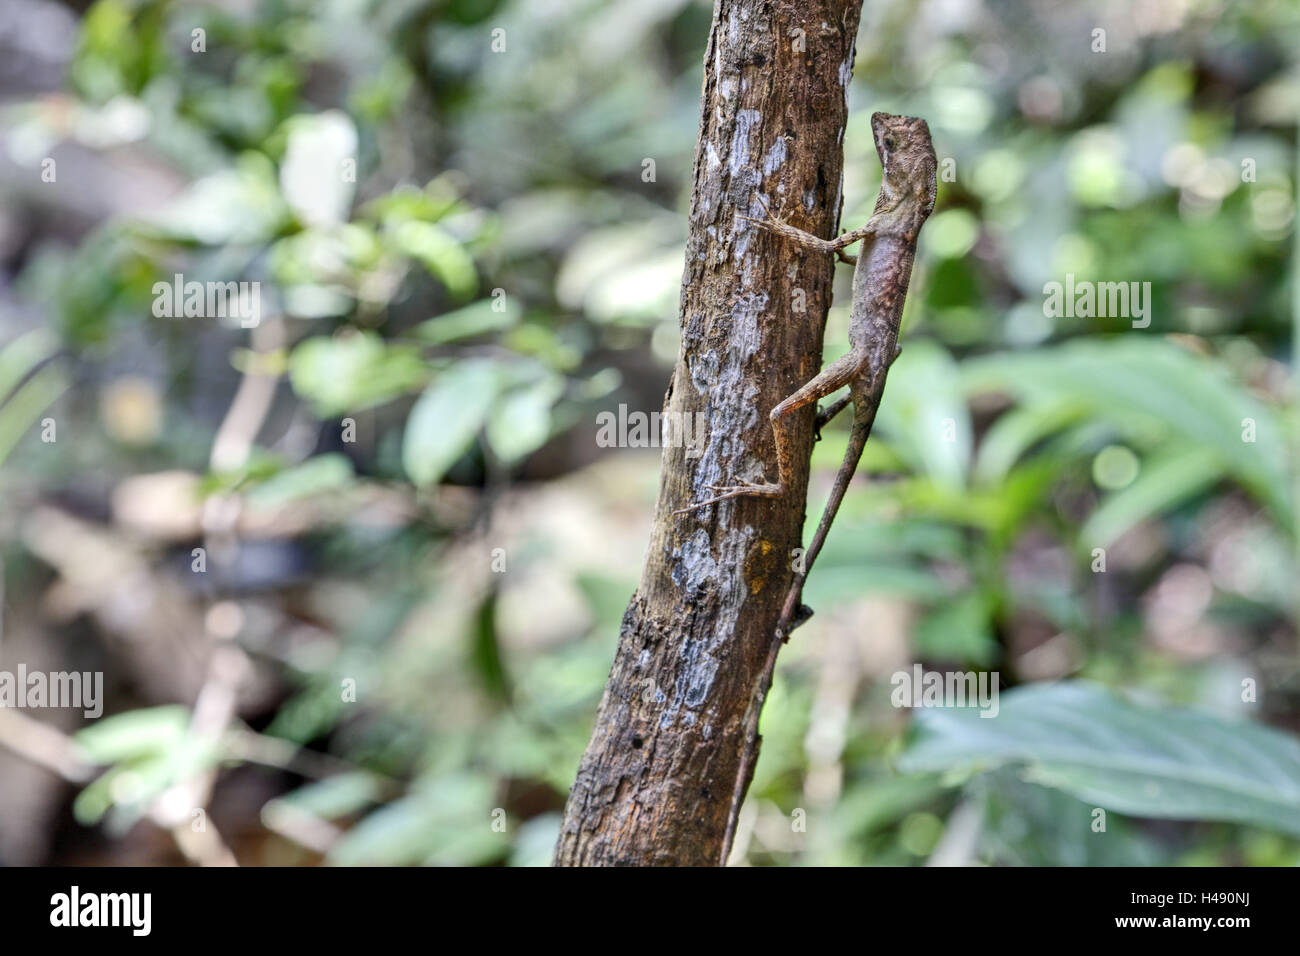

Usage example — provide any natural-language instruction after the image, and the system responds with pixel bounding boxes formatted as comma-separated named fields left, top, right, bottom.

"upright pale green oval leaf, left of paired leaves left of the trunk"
left=402, top=359, right=502, bottom=486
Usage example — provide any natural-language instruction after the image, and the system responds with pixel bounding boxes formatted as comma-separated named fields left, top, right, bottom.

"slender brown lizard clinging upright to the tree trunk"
left=673, top=113, right=937, bottom=641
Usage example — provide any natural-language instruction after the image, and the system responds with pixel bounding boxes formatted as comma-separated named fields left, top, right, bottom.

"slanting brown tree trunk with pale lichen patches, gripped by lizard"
left=555, top=0, right=862, bottom=866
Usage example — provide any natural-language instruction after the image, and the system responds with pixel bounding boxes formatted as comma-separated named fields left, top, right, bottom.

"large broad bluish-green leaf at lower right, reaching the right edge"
left=900, top=682, right=1300, bottom=835
